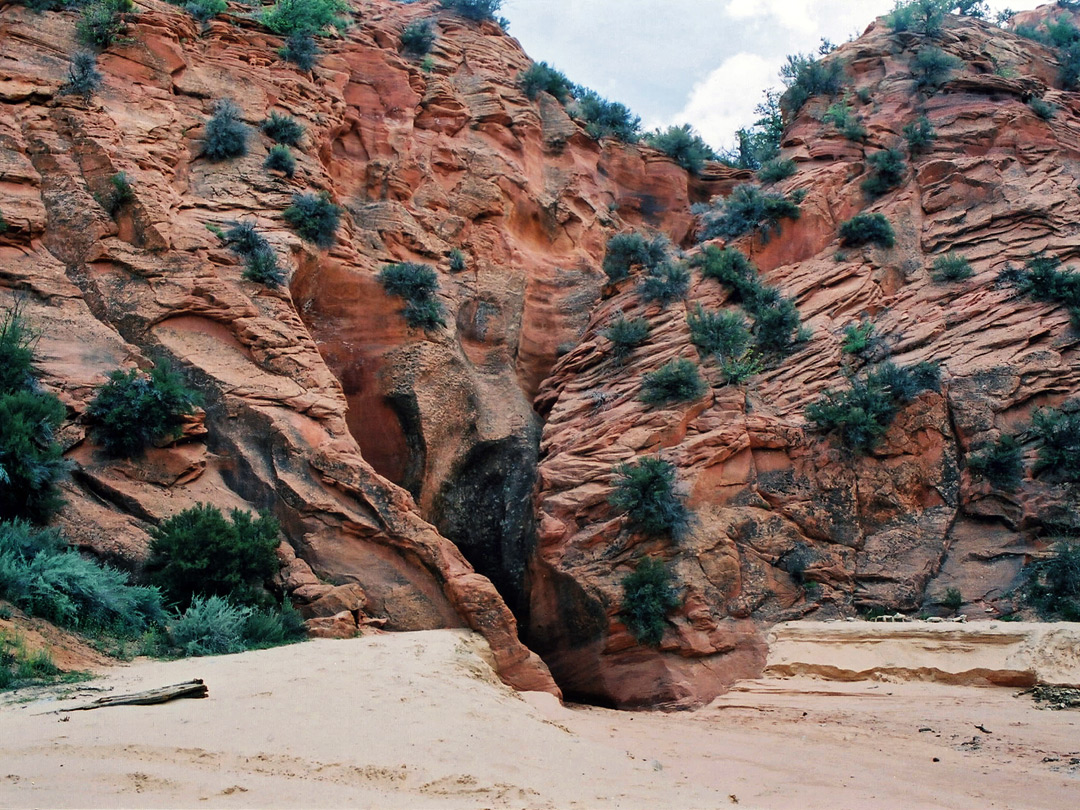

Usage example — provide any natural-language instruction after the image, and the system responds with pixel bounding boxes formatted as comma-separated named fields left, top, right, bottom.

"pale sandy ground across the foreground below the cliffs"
left=0, top=631, right=1080, bottom=810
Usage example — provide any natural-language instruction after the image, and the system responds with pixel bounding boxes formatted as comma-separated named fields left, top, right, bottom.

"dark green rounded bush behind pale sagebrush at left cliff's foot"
left=147, top=503, right=281, bottom=607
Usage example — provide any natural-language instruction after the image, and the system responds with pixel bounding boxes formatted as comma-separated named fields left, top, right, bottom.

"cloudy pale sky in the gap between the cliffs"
left=501, top=0, right=1040, bottom=148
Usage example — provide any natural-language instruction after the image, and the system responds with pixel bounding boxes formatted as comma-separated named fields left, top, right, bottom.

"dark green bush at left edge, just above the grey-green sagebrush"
left=0, top=391, right=67, bottom=523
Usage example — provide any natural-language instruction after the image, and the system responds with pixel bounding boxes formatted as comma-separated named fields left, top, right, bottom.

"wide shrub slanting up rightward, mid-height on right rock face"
left=806, top=363, right=940, bottom=453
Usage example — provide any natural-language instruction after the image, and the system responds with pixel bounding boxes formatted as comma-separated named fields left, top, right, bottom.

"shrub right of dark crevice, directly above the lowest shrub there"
left=608, top=456, right=689, bottom=537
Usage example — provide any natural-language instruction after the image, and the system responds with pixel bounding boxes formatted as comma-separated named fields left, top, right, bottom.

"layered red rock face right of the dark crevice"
left=529, top=11, right=1080, bottom=705
